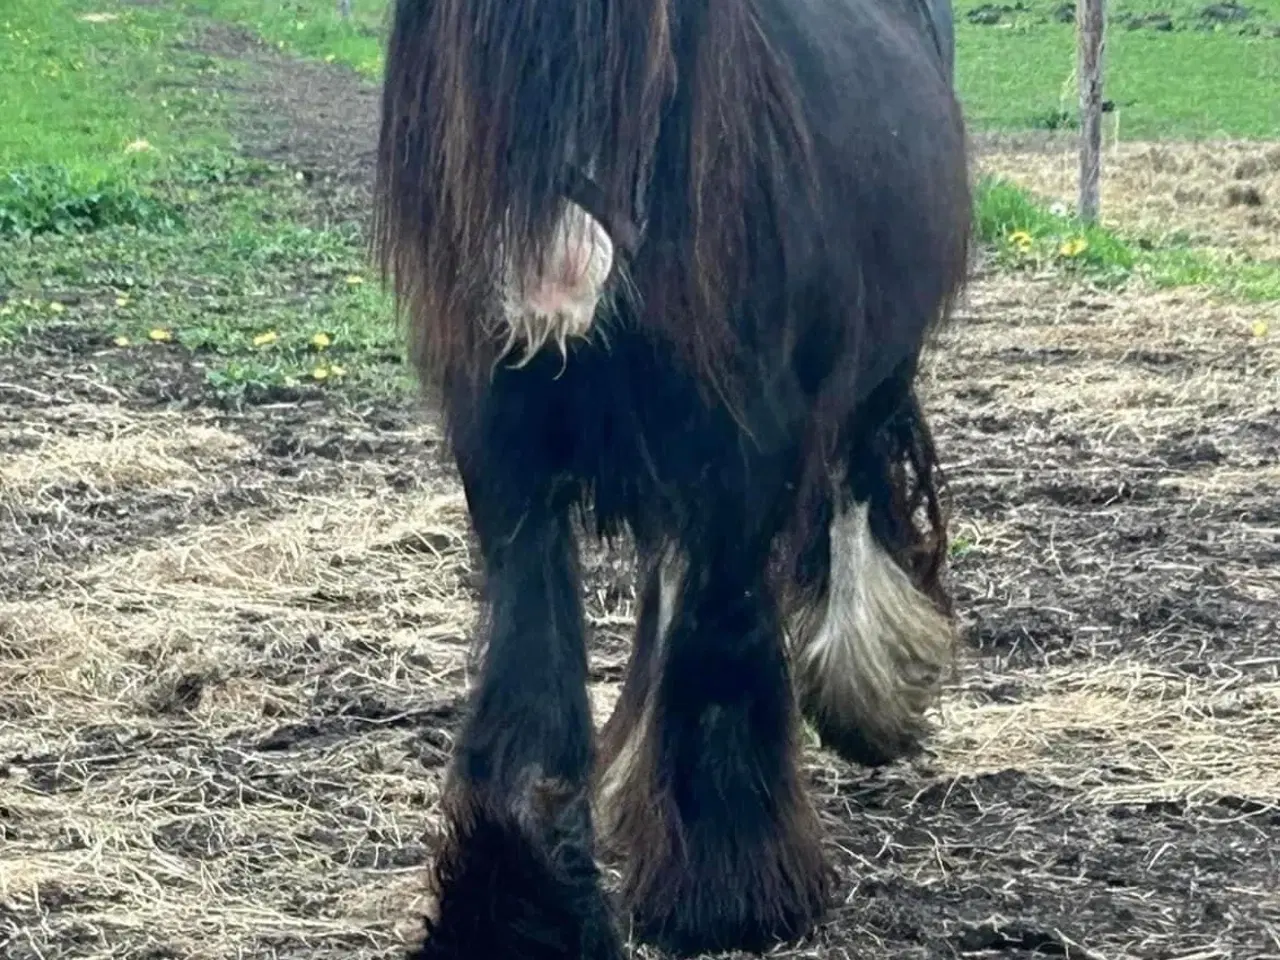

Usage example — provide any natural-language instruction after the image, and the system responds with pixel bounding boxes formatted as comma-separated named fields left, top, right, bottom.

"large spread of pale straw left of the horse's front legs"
left=0, top=493, right=474, bottom=957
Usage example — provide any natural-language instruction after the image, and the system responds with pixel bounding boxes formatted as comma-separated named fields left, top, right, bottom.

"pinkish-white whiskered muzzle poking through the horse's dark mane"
left=502, top=202, right=613, bottom=366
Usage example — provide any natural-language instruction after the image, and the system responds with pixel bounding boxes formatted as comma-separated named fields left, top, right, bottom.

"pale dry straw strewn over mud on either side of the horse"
left=0, top=264, right=1280, bottom=957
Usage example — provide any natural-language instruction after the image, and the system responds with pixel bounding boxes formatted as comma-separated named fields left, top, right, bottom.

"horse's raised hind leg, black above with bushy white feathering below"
left=792, top=366, right=955, bottom=765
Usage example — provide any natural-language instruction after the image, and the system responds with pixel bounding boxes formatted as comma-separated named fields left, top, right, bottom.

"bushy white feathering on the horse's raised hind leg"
left=792, top=503, right=955, bottom=764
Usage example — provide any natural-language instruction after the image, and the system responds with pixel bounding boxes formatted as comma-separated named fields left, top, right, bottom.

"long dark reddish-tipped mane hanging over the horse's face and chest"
left=374, top=0, right=815, bottom=398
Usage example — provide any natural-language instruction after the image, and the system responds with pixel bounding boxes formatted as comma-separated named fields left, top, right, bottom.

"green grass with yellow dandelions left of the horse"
left=0, top=0, right=407, bottom=394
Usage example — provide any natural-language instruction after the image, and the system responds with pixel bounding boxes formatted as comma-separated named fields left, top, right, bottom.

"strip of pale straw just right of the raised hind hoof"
left=937, top=657, right=1280, bottom=812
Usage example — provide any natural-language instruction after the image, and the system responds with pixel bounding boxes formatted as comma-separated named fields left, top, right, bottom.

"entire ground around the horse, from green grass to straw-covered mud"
left=0, top=0, right=1280, bottom=960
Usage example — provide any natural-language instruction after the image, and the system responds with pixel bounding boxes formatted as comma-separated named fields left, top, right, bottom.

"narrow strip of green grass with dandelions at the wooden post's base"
left=975, top=178, right=1280, bottom=301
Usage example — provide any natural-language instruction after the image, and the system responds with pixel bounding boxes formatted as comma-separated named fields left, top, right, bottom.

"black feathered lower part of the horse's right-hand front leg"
left=609, top=704, right=831, bottom=955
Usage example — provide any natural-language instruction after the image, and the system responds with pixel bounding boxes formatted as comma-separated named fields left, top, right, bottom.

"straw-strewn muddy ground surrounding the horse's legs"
left=0, top=15, right=1280, bottom=960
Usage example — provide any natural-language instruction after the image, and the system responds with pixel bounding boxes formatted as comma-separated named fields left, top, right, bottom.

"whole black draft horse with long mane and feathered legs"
left=375, top=0, right=970, bottom=960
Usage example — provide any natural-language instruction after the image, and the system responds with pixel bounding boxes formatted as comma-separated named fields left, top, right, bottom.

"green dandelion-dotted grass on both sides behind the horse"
left=0, top=0, right=1280, bottom=399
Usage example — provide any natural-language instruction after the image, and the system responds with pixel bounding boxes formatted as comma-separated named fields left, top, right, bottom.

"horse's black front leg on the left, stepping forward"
left=413, top=386, right=621, bottom=960
